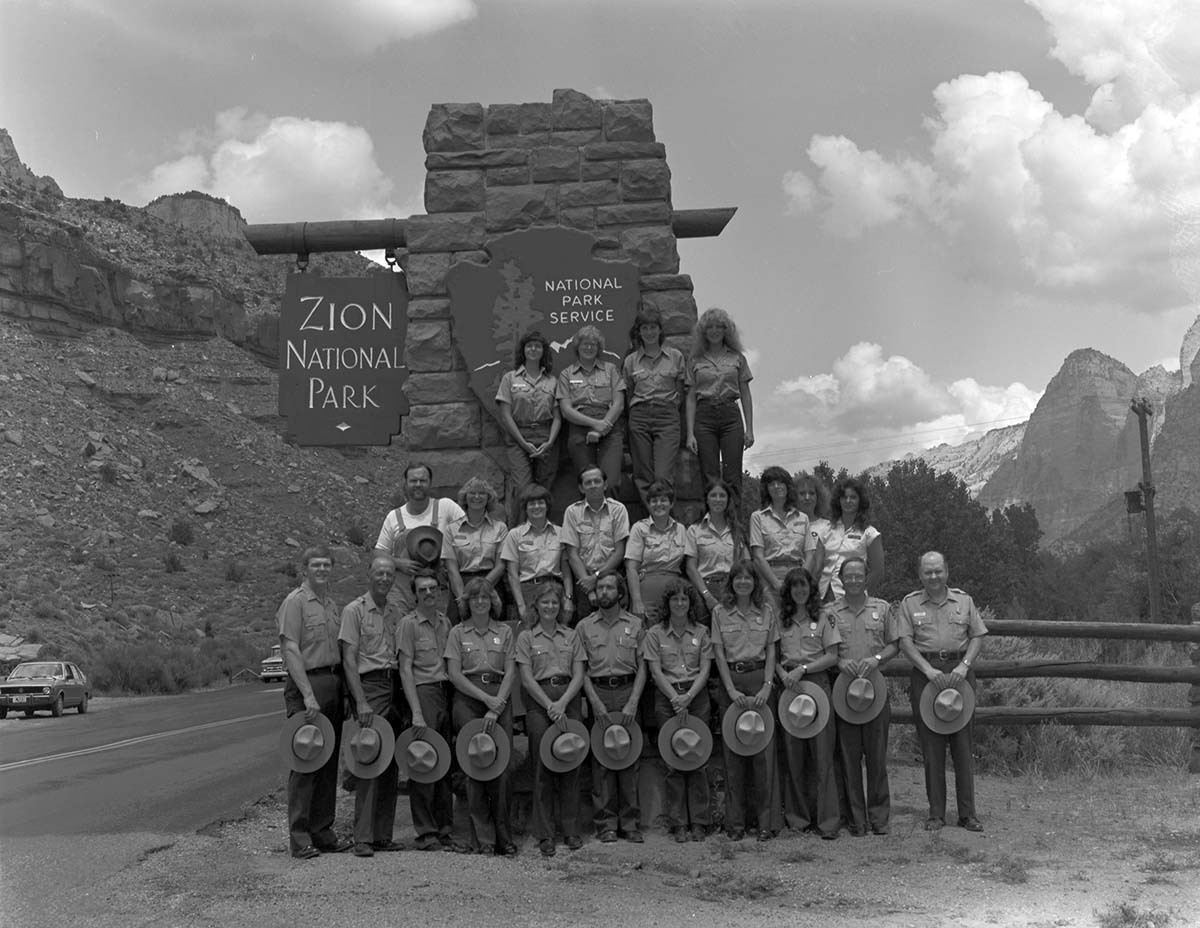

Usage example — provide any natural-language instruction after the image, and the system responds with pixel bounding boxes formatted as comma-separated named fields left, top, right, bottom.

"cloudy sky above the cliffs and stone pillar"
left=0, top=0, right=1200, bottom=471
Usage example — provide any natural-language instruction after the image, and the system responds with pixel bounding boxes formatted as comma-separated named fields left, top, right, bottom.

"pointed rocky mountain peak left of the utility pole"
left=979, top=348, right=1160, bottom=543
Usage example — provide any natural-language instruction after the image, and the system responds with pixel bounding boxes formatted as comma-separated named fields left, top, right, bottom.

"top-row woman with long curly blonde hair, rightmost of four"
left=684, top=307, right=754, bottom=492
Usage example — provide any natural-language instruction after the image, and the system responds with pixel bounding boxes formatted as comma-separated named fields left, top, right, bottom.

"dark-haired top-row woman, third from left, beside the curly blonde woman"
left=622, top=307, right=686, bottom=509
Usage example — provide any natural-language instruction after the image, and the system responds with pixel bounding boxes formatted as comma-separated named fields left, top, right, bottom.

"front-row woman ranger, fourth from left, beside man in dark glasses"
left=445, top=577, right=517, bottom=857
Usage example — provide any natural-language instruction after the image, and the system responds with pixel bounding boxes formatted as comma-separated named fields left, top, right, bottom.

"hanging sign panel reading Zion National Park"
left=280, top=274, right=408, bottom=445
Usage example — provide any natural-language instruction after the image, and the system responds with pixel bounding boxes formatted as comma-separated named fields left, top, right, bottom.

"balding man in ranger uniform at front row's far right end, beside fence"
left=895, top=551, right=988, bottom=831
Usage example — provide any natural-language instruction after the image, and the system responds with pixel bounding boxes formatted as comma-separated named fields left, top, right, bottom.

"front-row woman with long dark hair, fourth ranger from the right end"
left=713, top=561, right=779, bottom=842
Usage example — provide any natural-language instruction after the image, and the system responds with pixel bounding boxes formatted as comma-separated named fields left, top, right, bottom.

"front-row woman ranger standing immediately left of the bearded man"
left=516, top=582, right=587, bottom=857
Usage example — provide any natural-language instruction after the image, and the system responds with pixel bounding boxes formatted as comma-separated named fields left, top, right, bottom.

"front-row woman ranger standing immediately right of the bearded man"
left=642, top=580, right=713, bottom=844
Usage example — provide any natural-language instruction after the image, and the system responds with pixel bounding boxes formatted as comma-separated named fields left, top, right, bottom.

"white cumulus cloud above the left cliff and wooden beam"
left=138, top=108, right=418, bottom=222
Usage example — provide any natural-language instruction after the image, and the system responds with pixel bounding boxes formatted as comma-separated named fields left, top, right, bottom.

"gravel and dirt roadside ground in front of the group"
left=60, top=766, right=1200, bottom=928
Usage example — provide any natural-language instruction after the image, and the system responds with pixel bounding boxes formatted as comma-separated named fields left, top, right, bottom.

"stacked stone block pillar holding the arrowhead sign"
left=402, top=90, right=698, bottom=499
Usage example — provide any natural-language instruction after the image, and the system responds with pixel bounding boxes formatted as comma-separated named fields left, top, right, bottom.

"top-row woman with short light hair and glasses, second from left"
left=558, top=325, right=625, bottom=496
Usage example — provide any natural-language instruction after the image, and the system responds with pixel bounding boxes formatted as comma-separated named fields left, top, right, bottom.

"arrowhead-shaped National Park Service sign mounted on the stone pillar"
left=446, top=226, right=640, bottom=415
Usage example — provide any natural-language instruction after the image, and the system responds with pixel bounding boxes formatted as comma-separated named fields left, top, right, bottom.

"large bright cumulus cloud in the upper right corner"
left=784, top=0, right=1200, bottom=313
